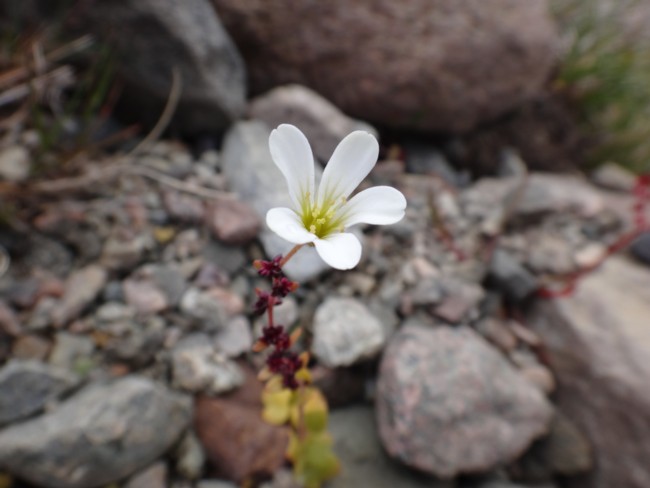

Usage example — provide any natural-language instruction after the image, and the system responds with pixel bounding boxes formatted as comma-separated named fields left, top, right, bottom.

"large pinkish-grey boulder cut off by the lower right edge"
left=527, top=256, right=650, bottom=488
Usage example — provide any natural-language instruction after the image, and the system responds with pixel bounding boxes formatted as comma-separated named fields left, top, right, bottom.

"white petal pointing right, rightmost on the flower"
left=339, top=186, right=406, bottom=228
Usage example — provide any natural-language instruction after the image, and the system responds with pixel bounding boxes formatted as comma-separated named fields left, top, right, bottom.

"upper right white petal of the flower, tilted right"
left=318, top=130, right=379, bottom=207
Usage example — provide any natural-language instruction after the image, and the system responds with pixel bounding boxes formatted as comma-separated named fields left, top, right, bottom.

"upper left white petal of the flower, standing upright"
left=269, top=124, right=314, bottom=210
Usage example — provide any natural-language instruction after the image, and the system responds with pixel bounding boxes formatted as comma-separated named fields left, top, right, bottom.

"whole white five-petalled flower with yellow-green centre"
left=266, top=124, right=406, bottom=269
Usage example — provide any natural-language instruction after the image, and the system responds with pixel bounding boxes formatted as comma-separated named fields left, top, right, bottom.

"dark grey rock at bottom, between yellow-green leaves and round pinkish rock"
left=328, top=406, right=454, bottom=488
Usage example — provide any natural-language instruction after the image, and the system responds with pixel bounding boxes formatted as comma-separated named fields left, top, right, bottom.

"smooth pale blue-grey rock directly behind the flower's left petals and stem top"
left=221, top=121, right=329, bottom=283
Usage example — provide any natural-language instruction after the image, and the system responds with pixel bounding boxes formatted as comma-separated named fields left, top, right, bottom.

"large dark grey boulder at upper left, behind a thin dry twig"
left=83, top=0, right=246, bottom=134
